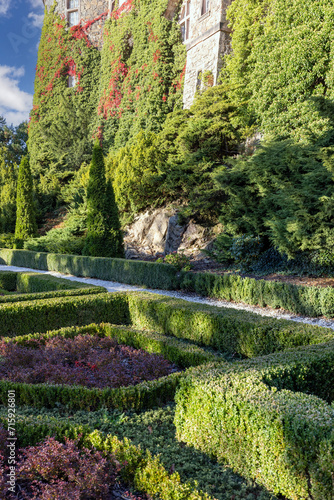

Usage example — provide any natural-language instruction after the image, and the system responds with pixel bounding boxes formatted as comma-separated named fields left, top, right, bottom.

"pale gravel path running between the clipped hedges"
left=0, top=265, right=334, bottom=330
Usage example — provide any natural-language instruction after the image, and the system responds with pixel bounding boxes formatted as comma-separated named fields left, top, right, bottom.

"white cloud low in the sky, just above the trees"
left=0, top=65, right=32, bottom=125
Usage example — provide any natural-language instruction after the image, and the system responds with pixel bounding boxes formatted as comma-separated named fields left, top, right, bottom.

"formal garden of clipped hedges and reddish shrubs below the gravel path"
left=0, top=264, right=334, bottom=500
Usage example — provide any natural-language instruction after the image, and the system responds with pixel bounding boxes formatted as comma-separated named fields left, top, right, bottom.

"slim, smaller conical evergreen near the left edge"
left=15, top=156, right=37, bottom=240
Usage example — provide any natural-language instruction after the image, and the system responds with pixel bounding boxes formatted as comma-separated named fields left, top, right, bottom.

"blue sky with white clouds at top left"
left=0, top=0, right=44, bottom=125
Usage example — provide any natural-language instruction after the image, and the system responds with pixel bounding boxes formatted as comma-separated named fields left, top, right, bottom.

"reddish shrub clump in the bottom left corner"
left=0, top=428, right=143, bottom=500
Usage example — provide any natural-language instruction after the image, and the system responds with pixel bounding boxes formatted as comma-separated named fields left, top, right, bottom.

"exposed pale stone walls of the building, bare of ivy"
left=43, top=0, right=232, bottom=108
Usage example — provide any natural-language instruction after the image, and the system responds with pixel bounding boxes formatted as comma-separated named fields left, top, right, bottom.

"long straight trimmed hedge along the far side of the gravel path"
left=0, top=249, right=334, bottom=318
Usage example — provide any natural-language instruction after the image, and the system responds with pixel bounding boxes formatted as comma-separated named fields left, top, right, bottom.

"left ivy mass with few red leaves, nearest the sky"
left=29, top=2, right=102, bottom=182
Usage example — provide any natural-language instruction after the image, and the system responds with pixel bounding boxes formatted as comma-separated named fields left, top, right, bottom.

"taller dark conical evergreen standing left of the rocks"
left=83, top=144, right=123, bottom=257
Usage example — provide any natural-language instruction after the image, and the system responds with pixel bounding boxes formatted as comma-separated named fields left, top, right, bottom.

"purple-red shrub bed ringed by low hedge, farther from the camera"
left=0, top=335, right=176, bottom=388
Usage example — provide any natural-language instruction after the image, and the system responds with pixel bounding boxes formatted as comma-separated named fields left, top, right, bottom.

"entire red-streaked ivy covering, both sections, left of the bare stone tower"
left=29, top=0, right=186, bottom=170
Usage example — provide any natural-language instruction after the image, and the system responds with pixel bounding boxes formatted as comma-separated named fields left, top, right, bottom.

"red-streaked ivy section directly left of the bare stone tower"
left=96, top=0, right=186, bottom=150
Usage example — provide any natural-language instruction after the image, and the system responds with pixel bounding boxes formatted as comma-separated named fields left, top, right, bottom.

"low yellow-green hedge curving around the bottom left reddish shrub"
left=0, top=419, right=212, bottom=500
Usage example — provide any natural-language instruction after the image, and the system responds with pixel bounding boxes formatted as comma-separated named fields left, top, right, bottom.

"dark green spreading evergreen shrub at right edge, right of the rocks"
left=215, top=99, right=334, bottom=257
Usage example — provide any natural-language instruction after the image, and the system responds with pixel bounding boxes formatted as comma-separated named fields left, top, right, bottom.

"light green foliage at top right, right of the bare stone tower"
left=225, top=0, right=334, bottom=142
